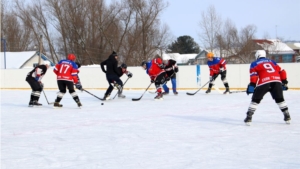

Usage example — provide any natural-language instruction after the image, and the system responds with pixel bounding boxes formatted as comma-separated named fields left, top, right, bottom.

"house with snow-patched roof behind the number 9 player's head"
left=253, top=39, right=296, bottom=63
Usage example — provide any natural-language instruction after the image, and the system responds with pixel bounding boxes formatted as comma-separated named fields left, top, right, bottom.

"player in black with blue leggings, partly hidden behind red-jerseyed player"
left=163, top=59, right=178, bottom=95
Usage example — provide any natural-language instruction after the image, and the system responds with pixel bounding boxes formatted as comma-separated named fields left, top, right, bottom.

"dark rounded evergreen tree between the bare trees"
left=167, top=35, right=200, bottom=54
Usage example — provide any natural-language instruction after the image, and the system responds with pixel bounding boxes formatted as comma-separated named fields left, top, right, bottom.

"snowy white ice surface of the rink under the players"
left=1, top=90, right=300, bottom=169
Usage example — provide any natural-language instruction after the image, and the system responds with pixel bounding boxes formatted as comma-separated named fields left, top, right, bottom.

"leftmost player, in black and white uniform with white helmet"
left=26, top=61, right=50, bottom=107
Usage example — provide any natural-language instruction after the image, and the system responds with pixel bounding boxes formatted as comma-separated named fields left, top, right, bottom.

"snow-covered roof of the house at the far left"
left=1, top=51, right=53, bottom=69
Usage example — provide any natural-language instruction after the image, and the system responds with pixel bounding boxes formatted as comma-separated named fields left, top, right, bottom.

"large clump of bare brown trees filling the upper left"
left=1, top=0, right=170, bottom=66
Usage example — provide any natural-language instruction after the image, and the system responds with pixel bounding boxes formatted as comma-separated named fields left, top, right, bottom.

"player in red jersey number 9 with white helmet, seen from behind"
left=244, top=50, right=291, bottom=125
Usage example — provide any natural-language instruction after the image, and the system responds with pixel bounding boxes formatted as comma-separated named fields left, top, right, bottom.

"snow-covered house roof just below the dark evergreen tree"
left=162, top=53, right=197, bottom=65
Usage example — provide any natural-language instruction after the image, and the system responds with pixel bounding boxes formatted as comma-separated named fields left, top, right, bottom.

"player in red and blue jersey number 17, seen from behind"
left=53, top=54, right=82, bottom=108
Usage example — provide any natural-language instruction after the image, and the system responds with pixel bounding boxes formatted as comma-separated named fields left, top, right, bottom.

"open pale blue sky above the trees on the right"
left=161, top=0, right=300, bottom=46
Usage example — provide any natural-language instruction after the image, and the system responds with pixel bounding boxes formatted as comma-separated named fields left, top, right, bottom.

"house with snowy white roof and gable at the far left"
left=1, top=51, right=54, bottom=69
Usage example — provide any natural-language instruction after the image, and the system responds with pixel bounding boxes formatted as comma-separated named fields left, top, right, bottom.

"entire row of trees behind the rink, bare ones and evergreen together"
left=1, top=0, right=276, bottom=66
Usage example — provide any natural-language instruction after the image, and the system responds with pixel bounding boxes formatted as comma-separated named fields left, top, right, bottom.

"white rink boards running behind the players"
left=1, top=63, right=300, bottom=90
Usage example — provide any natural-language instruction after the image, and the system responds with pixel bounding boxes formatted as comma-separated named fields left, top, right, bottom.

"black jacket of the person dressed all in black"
left=100, top=53, right=122, bottom=76
